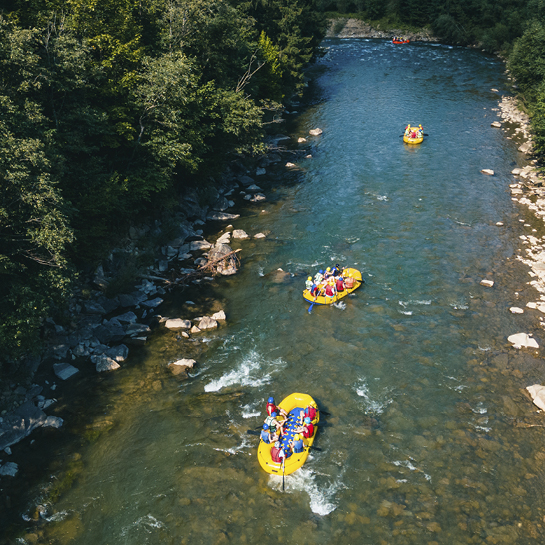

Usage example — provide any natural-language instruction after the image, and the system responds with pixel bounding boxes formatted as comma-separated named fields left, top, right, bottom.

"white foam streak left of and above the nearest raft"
left=204, top=350, right=285, bottom=392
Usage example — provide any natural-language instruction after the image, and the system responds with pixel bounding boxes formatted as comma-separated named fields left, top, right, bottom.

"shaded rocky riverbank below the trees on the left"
left=0, top=125, right=321, bottom=486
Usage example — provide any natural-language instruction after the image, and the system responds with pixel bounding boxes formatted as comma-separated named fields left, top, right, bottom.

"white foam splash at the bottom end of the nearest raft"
left=269, top=467, right=346, bottom=517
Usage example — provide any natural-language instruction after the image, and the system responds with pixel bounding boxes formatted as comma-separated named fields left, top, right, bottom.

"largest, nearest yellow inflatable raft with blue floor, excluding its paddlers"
left=257, top=393, right=320, bottom=475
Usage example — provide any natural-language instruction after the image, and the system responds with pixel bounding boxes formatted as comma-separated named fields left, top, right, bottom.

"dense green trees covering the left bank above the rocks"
left=0, top=0, right=325, bottom=370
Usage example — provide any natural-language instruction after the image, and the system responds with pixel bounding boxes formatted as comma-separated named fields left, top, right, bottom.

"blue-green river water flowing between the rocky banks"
left=13, top=40, right=545, bottom=545
